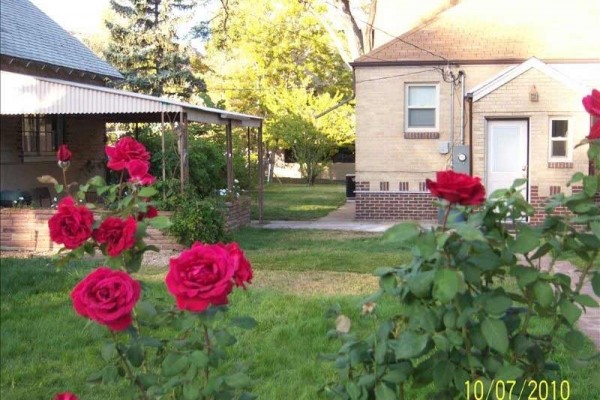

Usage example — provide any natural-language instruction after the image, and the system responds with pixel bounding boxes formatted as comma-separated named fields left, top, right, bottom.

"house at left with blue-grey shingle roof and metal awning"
left=0, top=0, right=262, bottom=200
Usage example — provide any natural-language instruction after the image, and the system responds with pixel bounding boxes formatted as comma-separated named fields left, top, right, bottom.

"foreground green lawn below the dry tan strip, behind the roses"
left=0, top=259, right=600, bottom=400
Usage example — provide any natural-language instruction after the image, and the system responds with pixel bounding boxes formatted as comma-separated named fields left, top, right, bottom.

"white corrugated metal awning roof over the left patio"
left=0, top=71, right=262, bottom=127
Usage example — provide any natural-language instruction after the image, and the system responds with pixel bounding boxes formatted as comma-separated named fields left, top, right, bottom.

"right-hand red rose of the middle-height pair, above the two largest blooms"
left=93, top=217, right=137, bottom=257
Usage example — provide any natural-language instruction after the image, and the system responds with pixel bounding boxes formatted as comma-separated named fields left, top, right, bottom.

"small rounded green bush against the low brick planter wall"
left=170, top=193, right=229, bottom=245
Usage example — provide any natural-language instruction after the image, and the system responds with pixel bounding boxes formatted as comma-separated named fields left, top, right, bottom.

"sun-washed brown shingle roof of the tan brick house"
left=355, top=0, right=600, bottom=65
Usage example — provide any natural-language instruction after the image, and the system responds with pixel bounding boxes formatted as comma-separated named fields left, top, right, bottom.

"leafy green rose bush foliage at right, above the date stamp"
left=326, top=141, right=600, bottom=399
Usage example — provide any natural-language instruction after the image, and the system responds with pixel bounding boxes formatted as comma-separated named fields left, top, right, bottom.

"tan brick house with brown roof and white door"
left=353, top=0, right=600, bottom=222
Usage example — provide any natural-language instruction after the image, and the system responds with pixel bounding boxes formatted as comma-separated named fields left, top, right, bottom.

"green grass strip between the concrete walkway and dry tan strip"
left=234, top=228, right=408, bottom=273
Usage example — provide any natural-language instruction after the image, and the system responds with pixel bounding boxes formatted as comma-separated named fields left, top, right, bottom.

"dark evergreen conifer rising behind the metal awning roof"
left=105, top=0, right=205, bottom=100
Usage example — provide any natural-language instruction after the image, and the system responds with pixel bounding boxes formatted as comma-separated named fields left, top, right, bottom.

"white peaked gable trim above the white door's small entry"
left=468, top=57, right=589, bottom=101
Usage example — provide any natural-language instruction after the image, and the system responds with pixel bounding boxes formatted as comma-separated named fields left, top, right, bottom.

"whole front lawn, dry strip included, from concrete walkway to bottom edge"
left=0, top=228, right=600, bottom=400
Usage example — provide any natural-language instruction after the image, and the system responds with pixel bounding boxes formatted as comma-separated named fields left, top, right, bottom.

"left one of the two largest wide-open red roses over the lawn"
left=71, top=267, right=141, bottom=331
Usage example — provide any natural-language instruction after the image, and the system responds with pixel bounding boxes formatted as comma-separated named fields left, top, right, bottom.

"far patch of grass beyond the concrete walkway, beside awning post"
left=252, top=183, right=346, bottom=221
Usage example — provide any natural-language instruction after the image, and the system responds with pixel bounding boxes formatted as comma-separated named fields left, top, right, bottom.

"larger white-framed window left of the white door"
left=404, top=83, right=439, bottom=132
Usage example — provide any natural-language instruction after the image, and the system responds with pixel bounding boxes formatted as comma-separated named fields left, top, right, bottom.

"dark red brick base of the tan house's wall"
left=355, top=182, right=438, bottom=221
